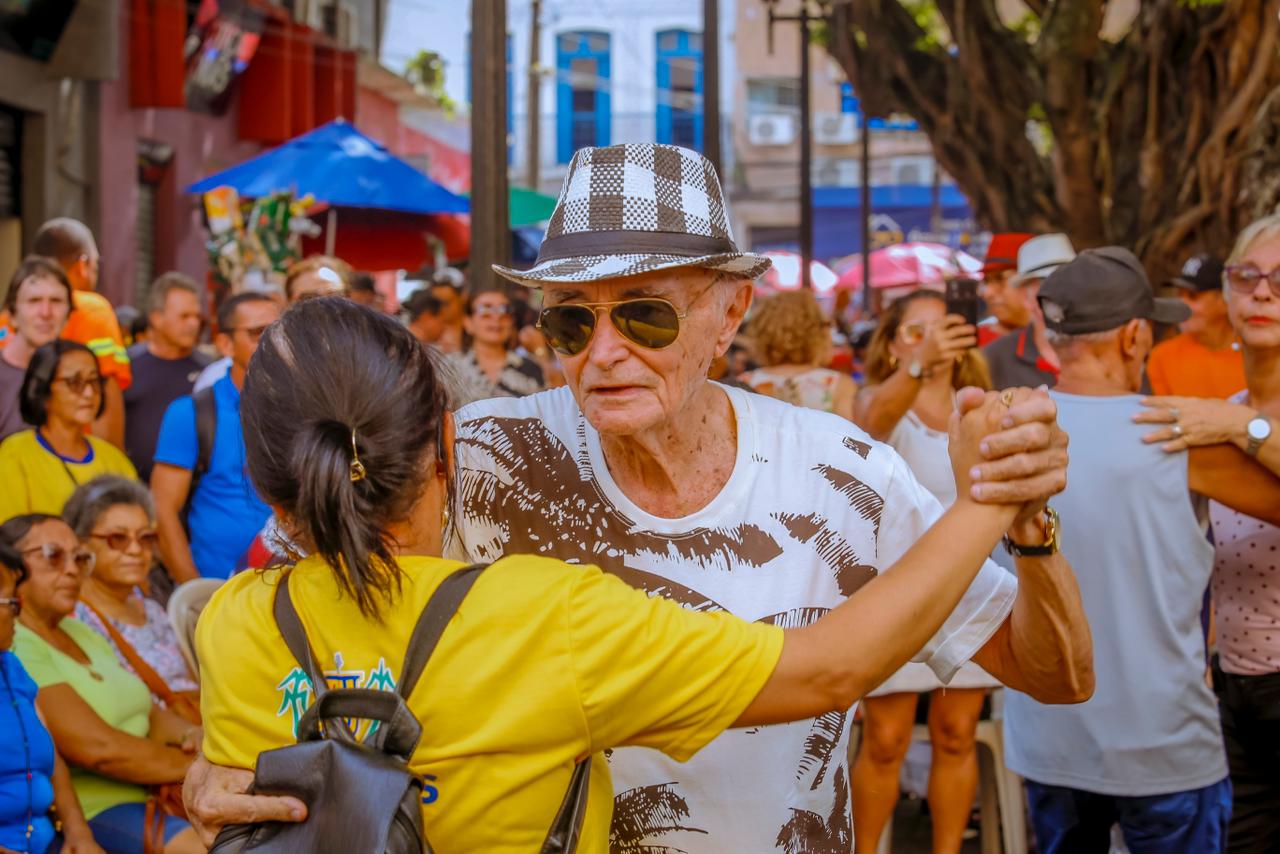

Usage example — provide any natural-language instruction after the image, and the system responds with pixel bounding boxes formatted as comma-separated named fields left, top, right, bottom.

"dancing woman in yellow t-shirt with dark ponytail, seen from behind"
left=188, top=297, right=1016, bottom=853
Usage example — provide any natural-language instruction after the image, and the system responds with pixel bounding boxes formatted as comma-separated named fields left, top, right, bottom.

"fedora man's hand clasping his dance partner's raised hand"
left=952, top=387, right=1069, bottom=526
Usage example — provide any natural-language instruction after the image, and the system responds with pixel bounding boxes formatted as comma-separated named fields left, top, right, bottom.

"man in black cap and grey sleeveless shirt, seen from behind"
left=1005, top=247, right=1280, bottom=854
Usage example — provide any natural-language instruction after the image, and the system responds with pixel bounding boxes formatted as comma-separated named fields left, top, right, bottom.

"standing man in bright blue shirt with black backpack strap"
left=151, top=292, right=280, bottom=584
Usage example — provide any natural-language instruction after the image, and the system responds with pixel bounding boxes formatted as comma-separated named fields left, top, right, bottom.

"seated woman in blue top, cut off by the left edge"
left=0, top=544, right=102, bottom=854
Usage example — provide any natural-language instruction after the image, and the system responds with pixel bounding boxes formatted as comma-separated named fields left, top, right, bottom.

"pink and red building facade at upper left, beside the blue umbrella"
left=0, top=0, right=387, bottom=305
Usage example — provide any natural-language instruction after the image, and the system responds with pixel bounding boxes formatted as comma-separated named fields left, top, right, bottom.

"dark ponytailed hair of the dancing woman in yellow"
left=241, top=297, right=444, bottom=617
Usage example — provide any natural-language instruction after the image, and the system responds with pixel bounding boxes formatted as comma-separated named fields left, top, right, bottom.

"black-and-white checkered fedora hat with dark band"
left=493, top=143, right=771, bottom=288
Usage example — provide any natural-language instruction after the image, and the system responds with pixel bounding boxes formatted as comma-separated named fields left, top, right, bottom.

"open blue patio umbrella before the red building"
left=187, top=120, right=471, bottom=217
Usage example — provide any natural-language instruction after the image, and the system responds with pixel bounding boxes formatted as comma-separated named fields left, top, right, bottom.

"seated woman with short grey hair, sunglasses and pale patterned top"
left=63, top=475, right=200, bottom=723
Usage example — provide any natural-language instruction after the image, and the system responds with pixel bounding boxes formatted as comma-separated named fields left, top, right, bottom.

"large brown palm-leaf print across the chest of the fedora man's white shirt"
left=456, top=417, right=782, bottom=594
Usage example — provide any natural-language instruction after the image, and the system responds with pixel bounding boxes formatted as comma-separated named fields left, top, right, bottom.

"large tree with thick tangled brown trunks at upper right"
left=824, top=0, right=1280, bottom=274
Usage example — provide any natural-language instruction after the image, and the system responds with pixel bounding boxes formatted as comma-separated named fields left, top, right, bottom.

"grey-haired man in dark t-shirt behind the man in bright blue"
left=124, top=273, right=214, bottom=483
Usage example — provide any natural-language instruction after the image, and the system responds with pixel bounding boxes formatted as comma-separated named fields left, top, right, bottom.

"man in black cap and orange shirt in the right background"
left=1147, top=254, right=1244, bottom=398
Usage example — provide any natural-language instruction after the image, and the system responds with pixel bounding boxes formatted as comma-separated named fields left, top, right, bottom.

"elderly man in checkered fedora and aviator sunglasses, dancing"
left=188, top=145, right=1092, bottom=853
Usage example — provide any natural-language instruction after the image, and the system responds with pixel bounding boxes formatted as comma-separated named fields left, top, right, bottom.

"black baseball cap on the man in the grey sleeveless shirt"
left=1039, top=246, right=1192, bottom=335
